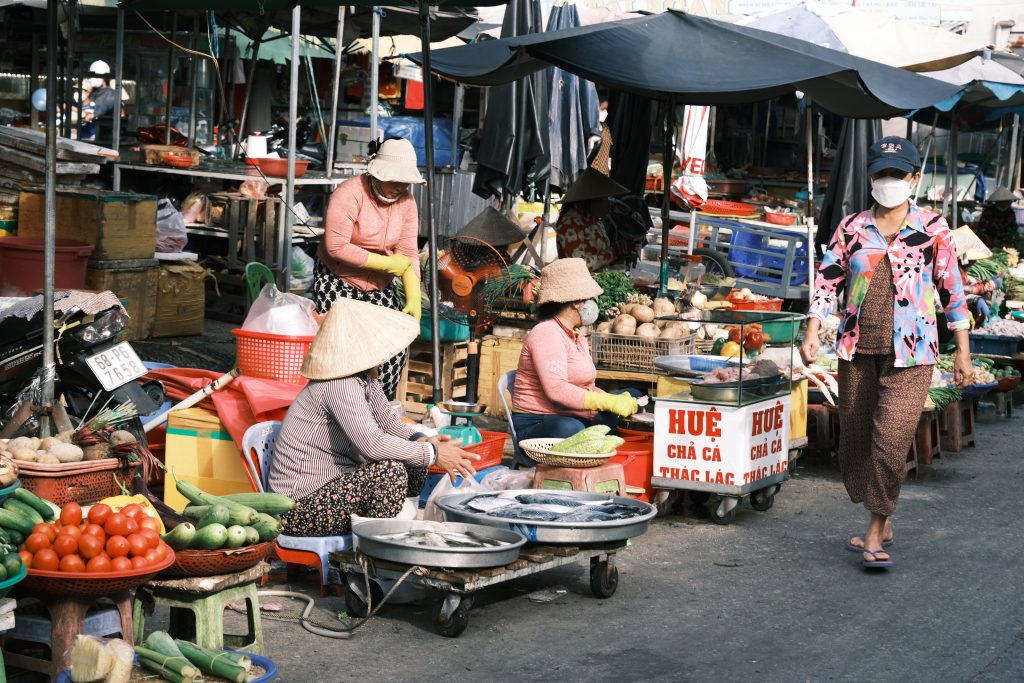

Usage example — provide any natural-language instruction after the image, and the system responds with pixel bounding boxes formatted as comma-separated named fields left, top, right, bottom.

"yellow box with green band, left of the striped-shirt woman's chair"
left=164, top=408, right=253, bottom=512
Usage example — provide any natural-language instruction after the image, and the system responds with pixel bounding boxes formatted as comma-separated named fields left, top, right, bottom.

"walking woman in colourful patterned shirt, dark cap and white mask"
left=800, top=137, right=972, bottom=569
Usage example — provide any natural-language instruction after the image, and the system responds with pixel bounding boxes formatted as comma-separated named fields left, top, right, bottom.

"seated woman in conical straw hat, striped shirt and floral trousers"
left=268, top=299, right=479, bottom=537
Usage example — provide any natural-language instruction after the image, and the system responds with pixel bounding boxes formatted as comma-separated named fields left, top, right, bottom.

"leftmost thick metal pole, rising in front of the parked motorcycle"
left=39, top=0, right=59, bottom=437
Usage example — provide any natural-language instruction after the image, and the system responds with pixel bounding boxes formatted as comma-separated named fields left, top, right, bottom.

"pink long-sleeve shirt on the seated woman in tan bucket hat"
left=512, top=318, right=600, bottom=420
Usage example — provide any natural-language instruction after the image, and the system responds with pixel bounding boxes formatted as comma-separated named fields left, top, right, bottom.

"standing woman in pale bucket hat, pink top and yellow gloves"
left=313, top=139, right=425, bottom=398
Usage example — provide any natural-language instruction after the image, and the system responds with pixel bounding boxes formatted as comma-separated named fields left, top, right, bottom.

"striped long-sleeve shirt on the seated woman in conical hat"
left=267, top=375, right=434, bottom=500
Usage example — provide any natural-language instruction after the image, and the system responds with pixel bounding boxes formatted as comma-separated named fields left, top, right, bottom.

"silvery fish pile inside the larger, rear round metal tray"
left=462, top=493, right=642, bottom=522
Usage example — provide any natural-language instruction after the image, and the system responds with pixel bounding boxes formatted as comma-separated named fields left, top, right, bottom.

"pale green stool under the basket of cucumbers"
left=133, top=562, right=270, bottom=654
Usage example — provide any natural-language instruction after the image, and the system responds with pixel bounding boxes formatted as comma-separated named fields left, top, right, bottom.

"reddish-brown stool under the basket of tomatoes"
left=4, top=591, right=134, bottom=680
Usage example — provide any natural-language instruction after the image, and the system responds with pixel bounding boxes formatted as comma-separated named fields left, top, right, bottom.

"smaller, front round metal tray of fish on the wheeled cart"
left=352, top=519, right=526, bottom=569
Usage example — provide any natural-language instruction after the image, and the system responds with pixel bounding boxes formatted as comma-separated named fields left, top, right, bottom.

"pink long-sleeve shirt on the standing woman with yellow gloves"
left=316, top=175, right=420, bottom=292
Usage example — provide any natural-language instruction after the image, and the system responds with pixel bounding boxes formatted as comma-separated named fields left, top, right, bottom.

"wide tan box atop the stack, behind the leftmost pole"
left=17, top=189, right=157, bottom=261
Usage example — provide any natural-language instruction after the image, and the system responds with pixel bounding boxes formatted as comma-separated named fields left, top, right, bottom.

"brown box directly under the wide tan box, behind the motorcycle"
left=85, top=258, right=160, bottom=341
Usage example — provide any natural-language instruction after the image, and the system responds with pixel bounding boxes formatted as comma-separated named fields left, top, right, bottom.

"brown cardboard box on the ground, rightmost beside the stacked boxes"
left=152, top=261, right=206, bottom=337
